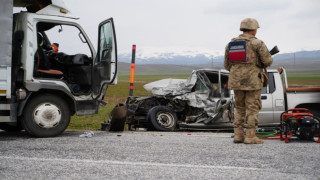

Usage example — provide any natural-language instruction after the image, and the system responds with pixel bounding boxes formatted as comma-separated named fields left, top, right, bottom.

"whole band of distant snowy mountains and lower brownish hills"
left=119, top=50, right=320, bottom=75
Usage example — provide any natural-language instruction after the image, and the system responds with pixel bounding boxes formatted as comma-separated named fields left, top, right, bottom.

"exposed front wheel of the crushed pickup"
left=147, top=106, right=178, bottom=131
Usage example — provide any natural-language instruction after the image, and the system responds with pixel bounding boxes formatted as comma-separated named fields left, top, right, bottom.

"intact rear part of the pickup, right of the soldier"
left=259, top=67, right=320, bottom=126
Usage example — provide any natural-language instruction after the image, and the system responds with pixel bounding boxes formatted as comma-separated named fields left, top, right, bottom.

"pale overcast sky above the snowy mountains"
left=64, top=0, right=320, bottom=53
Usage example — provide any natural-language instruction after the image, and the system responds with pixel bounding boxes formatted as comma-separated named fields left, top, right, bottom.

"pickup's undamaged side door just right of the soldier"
left=259, top=73, right=275, bottom=125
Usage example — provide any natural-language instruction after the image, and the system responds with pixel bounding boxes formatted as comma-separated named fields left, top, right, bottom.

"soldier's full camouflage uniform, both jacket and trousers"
left=224, top=19, right=273, bottom=144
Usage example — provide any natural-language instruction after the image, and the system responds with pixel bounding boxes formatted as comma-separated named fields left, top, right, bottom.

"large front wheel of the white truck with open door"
left=22, top=94, right=70, bottom=137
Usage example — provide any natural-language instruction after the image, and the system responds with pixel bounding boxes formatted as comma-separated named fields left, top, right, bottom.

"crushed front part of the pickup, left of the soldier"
left=126, top=69, right=234, bottom=131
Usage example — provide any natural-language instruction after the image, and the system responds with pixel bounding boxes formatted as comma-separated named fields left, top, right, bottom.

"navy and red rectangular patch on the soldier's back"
left=229, top=41, right=247, bottom=63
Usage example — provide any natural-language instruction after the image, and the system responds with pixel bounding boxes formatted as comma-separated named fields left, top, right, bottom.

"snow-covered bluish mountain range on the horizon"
left=118, top=50, right=320, bottom=65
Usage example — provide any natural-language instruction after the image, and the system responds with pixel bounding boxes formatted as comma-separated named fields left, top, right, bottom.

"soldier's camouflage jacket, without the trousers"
left=224, top=34, right=273, bottom=90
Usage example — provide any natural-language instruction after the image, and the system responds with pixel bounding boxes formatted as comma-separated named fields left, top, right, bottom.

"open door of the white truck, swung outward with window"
left=92, top=18, right=118, bottom=93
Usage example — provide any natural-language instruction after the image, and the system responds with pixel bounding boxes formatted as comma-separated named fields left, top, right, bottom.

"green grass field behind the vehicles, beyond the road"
left=68, top=71, right=320, bottom=130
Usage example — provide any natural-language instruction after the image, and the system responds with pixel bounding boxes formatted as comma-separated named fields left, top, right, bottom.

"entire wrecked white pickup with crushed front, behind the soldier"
left=121, top=68, right=320, bottom=131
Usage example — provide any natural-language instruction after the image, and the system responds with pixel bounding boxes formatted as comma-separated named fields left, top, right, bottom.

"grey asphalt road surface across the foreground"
left=0, top=131, right=320, bottom=180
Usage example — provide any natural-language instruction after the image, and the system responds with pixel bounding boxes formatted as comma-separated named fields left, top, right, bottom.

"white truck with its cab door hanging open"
left=0, top=0, right=117, bottom=137
